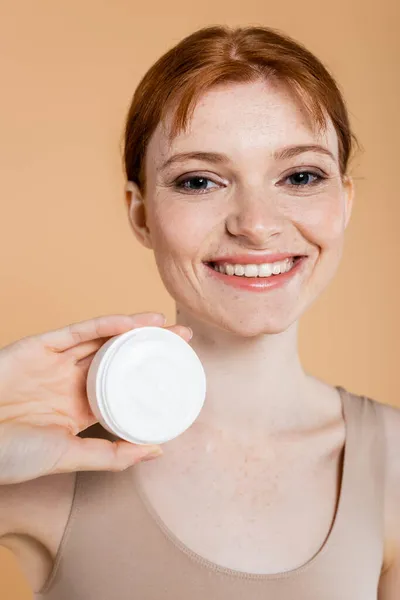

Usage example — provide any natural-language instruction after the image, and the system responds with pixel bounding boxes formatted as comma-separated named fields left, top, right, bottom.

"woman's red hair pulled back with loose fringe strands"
left=124, top=26, right=356, bottom=193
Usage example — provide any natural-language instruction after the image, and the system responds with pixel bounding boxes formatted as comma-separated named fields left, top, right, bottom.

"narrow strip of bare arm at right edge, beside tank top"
left=378, top=405, right=400, bottom=600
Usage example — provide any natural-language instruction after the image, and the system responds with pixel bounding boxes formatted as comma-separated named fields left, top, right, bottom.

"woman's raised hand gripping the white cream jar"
left=0, top=313, right=191, bottom=484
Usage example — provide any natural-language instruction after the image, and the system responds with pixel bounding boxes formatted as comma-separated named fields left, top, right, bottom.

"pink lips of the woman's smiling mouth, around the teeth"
left=205, top=254, right=307, bottom=292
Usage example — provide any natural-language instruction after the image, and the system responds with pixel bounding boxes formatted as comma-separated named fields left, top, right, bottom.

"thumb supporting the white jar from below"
left=52, top=437, right=163, bottom=473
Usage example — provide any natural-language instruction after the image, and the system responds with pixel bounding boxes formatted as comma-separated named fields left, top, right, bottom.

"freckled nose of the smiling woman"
left=226, top=189, right=284, bottom=248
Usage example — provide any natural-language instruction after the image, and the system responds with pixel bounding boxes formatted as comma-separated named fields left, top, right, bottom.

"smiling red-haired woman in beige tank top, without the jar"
left=1, top=27, right=400, bottom=600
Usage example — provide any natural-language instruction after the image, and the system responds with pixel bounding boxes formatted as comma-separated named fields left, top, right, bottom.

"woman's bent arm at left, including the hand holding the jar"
left=0, top=313, right=185, bottom=591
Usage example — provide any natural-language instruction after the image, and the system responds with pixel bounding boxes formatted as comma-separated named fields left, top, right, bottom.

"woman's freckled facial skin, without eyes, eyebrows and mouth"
left=131, top=82, right=352, bottom=336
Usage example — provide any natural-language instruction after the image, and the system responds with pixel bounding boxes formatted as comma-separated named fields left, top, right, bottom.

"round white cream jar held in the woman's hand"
left=87, top=327, right=206, bottom=444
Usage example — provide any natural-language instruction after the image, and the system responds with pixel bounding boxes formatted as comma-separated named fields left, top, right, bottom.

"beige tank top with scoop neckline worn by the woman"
left=37, top=388, right=384, bottom=600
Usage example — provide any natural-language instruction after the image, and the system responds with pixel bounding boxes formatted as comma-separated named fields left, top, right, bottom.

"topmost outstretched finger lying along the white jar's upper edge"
left=40, top=313, right=165, bottom=352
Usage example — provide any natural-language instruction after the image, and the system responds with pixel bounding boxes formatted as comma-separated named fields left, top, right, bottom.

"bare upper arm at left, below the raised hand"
left=0, top=473, right=76, bottom=591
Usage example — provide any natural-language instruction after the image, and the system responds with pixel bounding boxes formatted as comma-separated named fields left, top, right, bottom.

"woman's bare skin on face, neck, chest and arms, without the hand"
left=0, top=80, right=400, bottom=600
